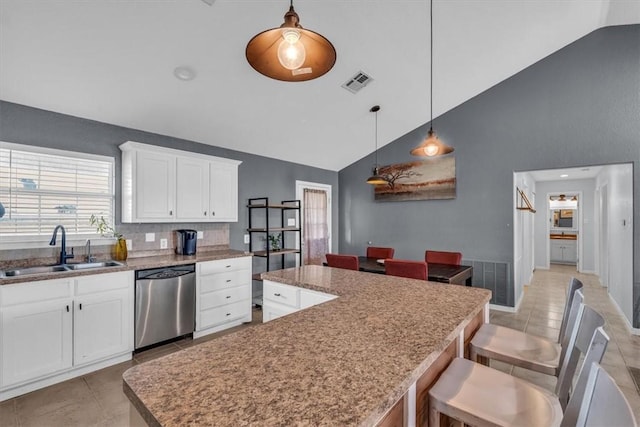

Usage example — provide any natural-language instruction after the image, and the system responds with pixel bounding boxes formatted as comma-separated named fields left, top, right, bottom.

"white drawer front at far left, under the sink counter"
left=0, top=278, right=73, bottom=307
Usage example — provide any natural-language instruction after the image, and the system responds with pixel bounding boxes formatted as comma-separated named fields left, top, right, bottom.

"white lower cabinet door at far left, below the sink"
left=2, top=299, right=73, bottom=387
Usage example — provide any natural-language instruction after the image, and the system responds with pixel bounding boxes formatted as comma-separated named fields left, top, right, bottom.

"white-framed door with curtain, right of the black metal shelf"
left=296, top=181, right=331, bottom=265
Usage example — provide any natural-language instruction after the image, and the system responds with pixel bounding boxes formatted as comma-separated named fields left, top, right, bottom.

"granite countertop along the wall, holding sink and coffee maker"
left=0, top=249, right=252, bottom=286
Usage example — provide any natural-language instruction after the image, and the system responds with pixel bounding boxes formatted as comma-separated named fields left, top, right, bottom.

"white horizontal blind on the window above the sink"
left=0, top=144, right=115, bottom=237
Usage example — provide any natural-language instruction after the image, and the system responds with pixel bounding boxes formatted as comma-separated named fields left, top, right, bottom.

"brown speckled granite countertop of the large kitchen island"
left=123, top=266, right=491, bottom=427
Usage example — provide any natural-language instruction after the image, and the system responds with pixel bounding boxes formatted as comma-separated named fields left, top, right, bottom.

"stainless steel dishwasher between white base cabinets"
left=135, top=264, right=196, bottom=350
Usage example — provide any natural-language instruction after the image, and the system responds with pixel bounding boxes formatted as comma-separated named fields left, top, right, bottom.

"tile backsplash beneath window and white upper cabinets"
left=0, top=223, right=229, bottom=263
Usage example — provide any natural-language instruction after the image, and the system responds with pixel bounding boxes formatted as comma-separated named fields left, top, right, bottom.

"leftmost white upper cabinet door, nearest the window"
left=133, top=151, right=176, bottom=221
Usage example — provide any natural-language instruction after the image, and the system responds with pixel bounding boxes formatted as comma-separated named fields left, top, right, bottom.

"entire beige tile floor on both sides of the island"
left=0, top=265, right=640, bottom=427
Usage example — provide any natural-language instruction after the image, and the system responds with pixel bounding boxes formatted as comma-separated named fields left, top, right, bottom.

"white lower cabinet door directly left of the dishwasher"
left=73, top=289, right=133, bottom=365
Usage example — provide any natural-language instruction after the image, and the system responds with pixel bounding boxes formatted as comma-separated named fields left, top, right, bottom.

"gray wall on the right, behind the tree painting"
left=339, top=25, right=640, bottom=327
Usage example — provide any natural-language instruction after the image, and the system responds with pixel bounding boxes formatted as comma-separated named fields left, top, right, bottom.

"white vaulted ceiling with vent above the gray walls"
left=0, top=0, right=640, bottom=170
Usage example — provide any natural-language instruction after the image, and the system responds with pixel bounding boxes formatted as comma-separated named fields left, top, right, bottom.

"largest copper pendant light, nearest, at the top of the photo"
left=245, top=0, right=336, bottom=82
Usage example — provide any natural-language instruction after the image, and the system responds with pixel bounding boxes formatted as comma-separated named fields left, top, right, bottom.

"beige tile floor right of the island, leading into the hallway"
left=491, top=264, right=640, bottom=420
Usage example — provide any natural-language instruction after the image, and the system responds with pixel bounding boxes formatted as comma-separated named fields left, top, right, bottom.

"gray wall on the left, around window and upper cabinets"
left=0, top=101, right=339, bottom=260
